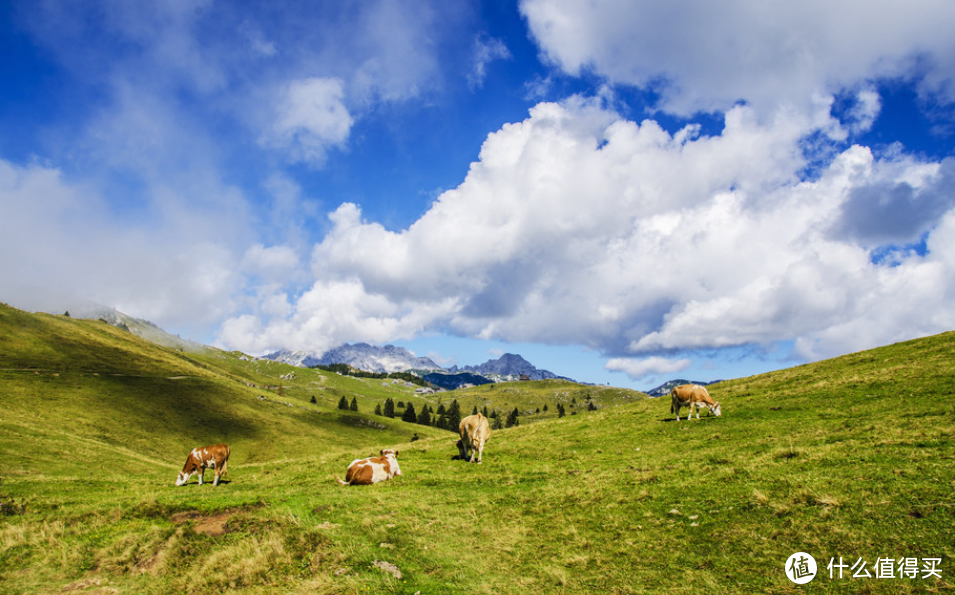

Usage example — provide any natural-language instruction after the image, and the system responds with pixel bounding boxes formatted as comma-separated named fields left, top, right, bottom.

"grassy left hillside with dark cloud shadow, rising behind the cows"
left=0, top=305, right=444, bottom=477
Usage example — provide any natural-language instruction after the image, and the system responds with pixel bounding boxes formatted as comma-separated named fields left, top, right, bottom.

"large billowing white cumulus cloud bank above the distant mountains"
left=218, top=98, right=955, bottom=360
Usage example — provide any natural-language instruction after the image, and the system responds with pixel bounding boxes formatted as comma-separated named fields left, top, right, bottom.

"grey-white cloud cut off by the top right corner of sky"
left=520, top=0, right=955, bottom=114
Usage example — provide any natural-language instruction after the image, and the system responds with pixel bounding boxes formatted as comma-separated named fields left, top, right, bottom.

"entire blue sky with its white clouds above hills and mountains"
left=0, top=0, right=955, bottom=389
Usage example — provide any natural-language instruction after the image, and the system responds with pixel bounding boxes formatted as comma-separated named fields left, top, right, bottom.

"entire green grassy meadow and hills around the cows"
left=0, top=306, right=955, bottom=595
